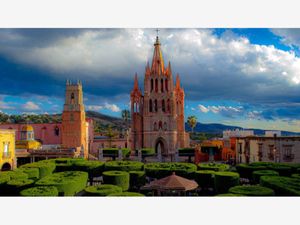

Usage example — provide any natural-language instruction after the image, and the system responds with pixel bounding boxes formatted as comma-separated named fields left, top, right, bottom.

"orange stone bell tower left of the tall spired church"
left=62, top=81, right=88, bottom=158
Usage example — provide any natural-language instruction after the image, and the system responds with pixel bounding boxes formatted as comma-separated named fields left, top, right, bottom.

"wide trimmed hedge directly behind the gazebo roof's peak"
left=144, top=162, right=197, bottom=178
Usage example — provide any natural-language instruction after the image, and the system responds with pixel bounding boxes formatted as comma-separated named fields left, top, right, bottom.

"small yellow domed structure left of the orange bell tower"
left=16, top=125, right=42, bottom=149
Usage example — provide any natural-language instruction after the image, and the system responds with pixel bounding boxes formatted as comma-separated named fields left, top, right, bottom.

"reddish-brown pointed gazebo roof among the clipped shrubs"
left=144, top=172, right=198, bottom=191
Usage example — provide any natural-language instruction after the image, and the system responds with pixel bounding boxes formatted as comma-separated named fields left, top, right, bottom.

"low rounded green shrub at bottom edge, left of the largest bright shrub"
left=20, top=186, right=58, bottom=197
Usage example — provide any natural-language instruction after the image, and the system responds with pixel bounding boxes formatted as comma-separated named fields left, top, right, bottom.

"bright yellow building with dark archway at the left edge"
left=0, top=129, right=16, bottom=170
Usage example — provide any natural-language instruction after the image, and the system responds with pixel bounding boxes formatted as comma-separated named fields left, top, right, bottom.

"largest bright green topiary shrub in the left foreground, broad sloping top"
left=36, top=171, right=88, bottom=196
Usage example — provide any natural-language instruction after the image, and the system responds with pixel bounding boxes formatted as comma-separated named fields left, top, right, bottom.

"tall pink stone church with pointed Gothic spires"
left=130, top=37, right=189, bottom=156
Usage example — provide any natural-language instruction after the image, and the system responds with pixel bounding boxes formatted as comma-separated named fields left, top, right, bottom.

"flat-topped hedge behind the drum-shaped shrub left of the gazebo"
left=105, top=161, right=144, bottom=172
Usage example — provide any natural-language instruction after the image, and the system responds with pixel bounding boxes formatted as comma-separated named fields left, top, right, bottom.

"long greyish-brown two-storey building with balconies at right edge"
left=236, top=136, right=300, bottom=163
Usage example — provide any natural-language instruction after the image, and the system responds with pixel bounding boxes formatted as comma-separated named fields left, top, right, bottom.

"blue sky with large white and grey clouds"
left=0, top=29, right=300, bottom=132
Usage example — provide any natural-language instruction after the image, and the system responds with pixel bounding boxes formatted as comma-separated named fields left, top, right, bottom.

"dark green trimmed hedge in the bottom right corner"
left=260, top=176, right=300, bottom=196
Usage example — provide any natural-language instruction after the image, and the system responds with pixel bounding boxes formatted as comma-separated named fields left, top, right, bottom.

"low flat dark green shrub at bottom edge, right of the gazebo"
left=229, top=185, right=275, bottom=196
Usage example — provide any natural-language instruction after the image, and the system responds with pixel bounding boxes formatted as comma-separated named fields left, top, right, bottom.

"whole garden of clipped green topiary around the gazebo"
left=0, top=158, right=300, bottom=197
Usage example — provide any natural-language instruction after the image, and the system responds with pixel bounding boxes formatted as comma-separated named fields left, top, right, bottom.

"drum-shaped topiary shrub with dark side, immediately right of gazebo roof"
left=215, top=172, right=240, bottom=194
